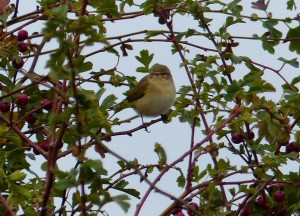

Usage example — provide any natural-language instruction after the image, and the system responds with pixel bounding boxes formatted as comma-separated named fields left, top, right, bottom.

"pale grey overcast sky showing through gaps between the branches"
left=3, top=0, right=299, bottom=216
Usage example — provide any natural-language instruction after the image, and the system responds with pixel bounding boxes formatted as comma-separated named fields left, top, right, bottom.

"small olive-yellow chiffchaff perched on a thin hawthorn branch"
left=115, top=64, right=176, bottom=117
